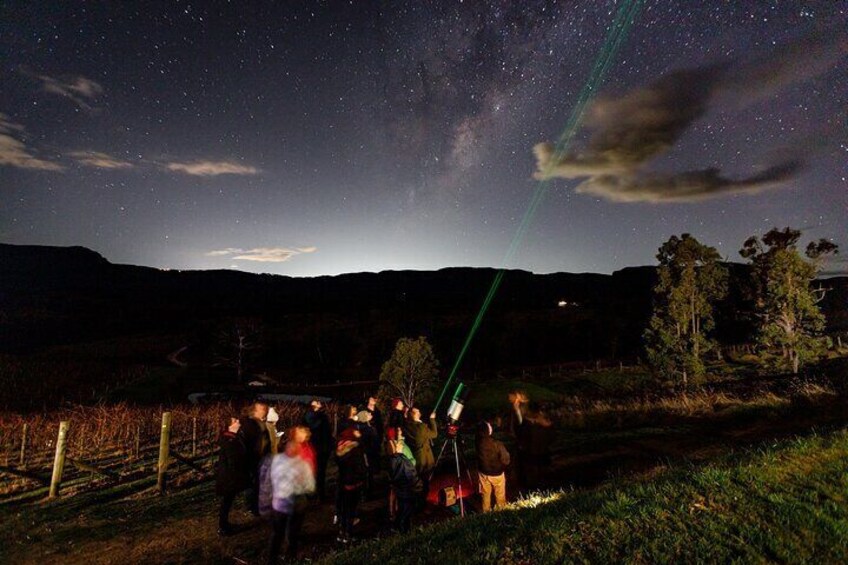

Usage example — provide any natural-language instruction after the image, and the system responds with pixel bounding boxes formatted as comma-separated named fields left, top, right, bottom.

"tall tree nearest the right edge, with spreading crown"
left=739, top=227, right=838, bottom=374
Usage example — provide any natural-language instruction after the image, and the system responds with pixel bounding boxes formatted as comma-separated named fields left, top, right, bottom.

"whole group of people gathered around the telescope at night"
left=216, top=396, right=546, bottom=563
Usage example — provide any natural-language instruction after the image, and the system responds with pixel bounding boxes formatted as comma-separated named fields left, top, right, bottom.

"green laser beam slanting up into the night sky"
left=433, top=0, right=644, bottom=411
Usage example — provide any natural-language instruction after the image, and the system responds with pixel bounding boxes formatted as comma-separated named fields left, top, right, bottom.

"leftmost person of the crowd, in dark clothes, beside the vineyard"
left=215, top=416, right=250, bottom=536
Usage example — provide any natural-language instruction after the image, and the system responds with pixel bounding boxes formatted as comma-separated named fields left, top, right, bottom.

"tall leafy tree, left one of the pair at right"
left=644, top=233, right=727, bottom=389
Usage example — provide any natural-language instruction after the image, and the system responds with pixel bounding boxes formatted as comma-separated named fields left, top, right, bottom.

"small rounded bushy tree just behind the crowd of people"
left=380, top=337, right=439, bottom=406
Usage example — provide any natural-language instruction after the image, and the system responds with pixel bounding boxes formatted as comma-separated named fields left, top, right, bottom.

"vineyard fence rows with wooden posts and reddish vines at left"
left=0, top=403, right=335, bottom=504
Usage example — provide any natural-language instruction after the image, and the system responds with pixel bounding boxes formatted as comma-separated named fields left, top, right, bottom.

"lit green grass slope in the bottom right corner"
left=326, top=431, right=848, bottom=564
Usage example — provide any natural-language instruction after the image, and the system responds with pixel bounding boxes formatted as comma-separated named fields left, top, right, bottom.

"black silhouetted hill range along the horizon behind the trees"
left=0, top=241, right=848, bottom=375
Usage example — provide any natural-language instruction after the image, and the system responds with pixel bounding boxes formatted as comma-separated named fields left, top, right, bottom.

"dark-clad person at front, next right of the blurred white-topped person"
left=336, top=427, right=368, bottom=543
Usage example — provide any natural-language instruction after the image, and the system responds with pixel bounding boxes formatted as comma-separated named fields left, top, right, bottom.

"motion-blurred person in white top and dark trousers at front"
left=268, top=439, right=315, bottom=564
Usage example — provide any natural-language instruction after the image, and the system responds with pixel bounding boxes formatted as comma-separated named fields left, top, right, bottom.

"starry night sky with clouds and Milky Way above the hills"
left=0, top=0, right=848, bottom=276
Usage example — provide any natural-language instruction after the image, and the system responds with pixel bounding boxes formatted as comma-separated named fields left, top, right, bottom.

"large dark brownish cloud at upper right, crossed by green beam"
left=533, top=29, right=848, bottom=202
